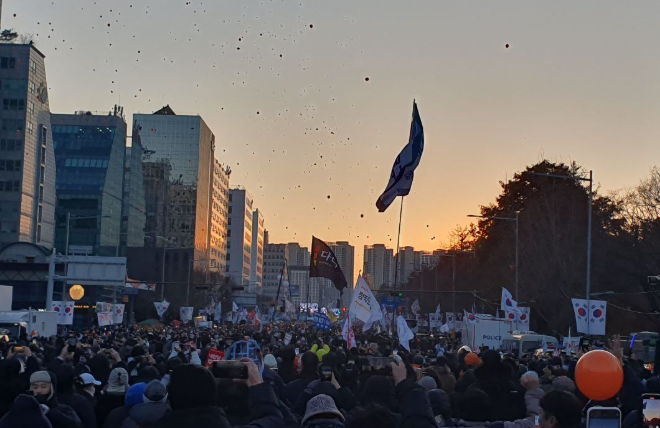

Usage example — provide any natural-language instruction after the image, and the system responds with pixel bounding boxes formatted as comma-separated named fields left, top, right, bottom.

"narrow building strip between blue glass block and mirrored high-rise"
left=119, top=120, right=147, bottom=252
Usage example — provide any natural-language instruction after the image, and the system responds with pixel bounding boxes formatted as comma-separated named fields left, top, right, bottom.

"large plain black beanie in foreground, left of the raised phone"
left=168, top=364, right=217, bottom=410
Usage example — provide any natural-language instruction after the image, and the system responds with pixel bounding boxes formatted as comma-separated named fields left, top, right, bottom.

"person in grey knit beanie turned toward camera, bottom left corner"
left=30, top=371, right=83, bottom=428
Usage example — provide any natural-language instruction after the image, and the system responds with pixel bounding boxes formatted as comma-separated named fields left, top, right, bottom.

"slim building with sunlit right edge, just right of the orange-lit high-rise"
left=227, top=186, right=253, bottom=286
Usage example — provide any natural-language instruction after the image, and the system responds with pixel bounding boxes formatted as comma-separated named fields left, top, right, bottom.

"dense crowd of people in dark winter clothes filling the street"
left=0, top=323, right=660, bottom=428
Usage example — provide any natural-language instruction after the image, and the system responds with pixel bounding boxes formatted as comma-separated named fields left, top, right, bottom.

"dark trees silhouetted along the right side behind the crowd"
left=407, top=161, right=660, bottom=335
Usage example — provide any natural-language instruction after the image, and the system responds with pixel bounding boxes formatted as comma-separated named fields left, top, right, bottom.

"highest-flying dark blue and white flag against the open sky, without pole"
left=376, top=101, right=424, bottom=212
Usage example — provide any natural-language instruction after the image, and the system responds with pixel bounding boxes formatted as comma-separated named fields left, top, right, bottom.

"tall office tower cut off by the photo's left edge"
left=0, top=43, right=55, bottom=249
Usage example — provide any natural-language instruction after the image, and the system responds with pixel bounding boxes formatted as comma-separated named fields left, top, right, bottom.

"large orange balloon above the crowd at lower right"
left=575, top=350, right=623, bottom=401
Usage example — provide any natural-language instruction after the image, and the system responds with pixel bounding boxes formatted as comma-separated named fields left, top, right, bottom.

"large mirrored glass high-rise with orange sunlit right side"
left=133, top=106, right=222, bottom=272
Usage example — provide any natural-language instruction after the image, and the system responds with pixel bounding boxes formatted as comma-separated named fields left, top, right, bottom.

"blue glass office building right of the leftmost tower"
left=51, top=106, right=126, bottom=256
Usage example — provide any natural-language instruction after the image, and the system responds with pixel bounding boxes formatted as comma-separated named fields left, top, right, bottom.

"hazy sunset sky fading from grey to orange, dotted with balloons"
left=2, top=0, right=660, bottom=278
